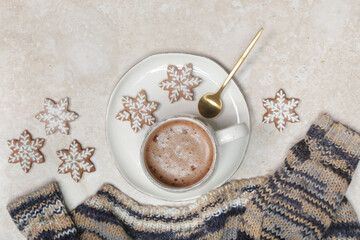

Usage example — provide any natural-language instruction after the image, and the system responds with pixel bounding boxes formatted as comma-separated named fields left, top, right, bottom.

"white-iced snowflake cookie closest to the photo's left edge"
left=8, top=130, right=45, bottom=173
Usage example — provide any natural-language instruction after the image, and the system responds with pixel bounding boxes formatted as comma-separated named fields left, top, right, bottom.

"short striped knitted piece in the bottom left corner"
left=7, top=183, right=78, bottom=240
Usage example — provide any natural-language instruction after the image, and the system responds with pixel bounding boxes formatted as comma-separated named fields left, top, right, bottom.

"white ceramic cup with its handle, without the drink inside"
left=140, top=115, right=249, bottom=192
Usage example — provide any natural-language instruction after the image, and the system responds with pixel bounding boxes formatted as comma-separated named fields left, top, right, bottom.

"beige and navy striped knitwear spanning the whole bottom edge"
left=8, top=115, right=360, bottom=240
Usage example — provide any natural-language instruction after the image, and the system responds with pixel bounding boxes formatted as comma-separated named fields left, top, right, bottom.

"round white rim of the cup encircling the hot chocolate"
left=140, top=114, right=219, bottom=192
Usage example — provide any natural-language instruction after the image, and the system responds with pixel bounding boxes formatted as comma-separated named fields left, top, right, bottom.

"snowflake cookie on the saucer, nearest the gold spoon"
left=159, top=63, right=201, bottom=103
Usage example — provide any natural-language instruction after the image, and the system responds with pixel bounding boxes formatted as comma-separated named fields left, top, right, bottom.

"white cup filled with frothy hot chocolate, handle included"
left=140, top=115, right=248, bottom=191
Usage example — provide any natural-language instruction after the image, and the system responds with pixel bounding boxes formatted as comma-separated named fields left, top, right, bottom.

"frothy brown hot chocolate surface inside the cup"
left=144, top=120, right=214, bottom=187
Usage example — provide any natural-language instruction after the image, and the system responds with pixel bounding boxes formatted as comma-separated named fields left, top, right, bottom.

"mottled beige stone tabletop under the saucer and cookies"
left=0, top=0, right=360, bottom=239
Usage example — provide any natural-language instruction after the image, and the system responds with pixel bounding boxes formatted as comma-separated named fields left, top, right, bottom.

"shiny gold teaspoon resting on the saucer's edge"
left=198, top=28, right=263, bottom=118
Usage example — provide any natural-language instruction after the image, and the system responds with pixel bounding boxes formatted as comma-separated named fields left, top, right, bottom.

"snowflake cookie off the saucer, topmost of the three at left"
left=35, top=97, right=78, bottom=135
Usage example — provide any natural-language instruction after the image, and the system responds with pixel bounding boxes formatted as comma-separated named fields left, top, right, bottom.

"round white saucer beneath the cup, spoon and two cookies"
left=106, top=53, right=250, bottom=201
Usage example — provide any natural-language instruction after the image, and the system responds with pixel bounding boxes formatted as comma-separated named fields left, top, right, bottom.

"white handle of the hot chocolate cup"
left=215, top=123, right=249, bottom=145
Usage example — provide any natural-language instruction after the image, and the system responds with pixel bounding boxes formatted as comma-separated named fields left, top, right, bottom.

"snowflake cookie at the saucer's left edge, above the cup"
left=116, top=90, right=159, bottom=132
